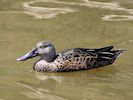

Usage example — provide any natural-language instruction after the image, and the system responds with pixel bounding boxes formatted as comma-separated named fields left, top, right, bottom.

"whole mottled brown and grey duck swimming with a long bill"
left=17, top=41, right=124, bottom=72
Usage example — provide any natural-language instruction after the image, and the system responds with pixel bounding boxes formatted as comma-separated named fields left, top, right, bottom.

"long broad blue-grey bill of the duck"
left=16, top=48, right=38, bottom=61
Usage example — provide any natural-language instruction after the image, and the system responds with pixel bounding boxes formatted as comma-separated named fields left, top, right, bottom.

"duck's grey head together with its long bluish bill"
left=17, top=41, right=56, bottom=62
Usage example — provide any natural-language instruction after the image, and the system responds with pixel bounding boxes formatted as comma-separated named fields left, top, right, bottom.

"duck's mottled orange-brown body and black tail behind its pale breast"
left=55, top=46, right=123, bottom=71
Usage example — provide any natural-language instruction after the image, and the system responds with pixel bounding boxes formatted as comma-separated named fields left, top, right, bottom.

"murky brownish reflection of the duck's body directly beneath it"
left=34, top=66, right=117, bottom=87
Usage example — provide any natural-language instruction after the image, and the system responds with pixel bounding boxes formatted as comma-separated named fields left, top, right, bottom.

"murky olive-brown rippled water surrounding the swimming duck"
left=0, top=0, right=133, bottom=100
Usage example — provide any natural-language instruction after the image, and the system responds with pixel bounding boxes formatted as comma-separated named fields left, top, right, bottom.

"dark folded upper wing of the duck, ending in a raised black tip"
left=57, top=46, right=113, bottom=61
